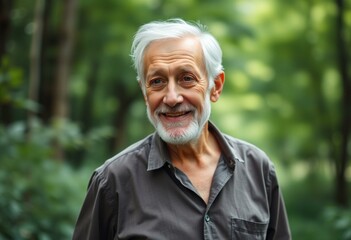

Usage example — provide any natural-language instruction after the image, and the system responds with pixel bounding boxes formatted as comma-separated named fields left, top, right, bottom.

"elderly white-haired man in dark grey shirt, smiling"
left=73, top=19, right=291, bottom=240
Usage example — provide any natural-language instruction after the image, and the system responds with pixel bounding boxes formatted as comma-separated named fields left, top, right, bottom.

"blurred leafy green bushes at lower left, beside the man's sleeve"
left=0, top=122, right=99, bottom=239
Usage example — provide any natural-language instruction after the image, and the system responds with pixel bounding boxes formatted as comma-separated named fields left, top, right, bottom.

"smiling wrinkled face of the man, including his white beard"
left=144, top=37, right=211, bottom=144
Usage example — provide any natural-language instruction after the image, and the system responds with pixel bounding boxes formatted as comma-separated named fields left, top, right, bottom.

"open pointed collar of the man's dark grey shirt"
left=147, top=121, right=244, bottom=171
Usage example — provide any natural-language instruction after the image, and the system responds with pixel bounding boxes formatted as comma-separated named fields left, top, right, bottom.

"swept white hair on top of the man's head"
left=131, top=18, right=223, bottom=91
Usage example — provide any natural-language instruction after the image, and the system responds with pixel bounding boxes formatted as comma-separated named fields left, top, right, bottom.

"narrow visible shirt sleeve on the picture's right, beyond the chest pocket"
left=266, top=166, right=291, bottom=240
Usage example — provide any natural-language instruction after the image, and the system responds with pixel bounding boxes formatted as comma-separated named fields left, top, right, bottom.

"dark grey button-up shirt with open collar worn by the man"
left=73, top=123, right=291, bottom=240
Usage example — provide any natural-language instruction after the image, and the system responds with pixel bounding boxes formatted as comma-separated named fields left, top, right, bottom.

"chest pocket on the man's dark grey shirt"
left=231, top=218, right=268, bottom=240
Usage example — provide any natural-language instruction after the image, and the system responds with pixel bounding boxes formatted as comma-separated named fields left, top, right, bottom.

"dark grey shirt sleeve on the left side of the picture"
left=72, top=172, right=118, bottom=240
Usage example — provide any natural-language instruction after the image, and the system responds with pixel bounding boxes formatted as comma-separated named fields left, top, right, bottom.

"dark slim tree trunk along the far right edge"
left=336, top=0, right=351, bottom=207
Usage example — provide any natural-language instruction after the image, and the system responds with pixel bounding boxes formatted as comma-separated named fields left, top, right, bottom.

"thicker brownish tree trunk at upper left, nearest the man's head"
left=53, top=0, right=77, bottom=160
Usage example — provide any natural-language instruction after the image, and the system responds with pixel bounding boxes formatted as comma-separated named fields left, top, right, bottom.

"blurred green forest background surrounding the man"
left=0, top=0, right=351, bottom=240
